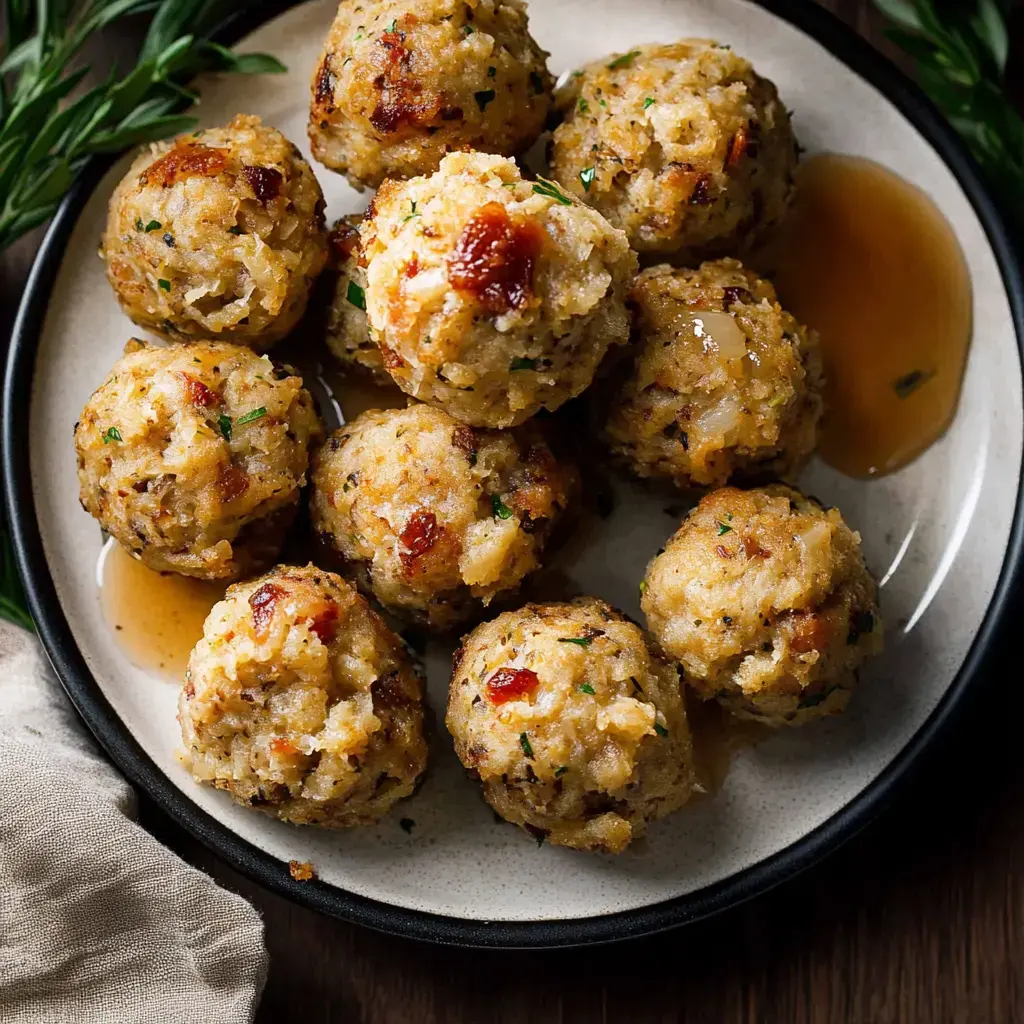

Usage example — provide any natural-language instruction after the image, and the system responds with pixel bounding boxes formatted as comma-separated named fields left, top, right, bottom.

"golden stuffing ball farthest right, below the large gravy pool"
left=641, top=484, right=882, bottom=726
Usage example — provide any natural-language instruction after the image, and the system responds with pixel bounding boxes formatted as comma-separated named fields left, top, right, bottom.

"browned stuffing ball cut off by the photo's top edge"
left=309, top=0, right=553, bottom=188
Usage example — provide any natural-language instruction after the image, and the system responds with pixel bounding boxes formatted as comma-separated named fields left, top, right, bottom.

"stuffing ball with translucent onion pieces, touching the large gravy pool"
left=599, top=259, right=822, bottom=488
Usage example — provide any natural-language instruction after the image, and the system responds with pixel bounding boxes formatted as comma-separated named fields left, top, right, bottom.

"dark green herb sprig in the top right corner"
left=874, top=0, right=1024, bottom=232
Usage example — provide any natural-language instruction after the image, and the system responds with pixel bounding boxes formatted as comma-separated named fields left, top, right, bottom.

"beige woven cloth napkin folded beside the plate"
left=0, top=623, right=266, bottom=1024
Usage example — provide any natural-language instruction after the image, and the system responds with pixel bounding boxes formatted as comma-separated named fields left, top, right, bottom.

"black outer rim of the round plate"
left=2, top=0, right=1024, bottom=948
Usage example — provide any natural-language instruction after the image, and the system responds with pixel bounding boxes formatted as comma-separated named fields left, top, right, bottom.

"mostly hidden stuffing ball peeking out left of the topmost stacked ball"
left=327, top=214, right=393, bottom=385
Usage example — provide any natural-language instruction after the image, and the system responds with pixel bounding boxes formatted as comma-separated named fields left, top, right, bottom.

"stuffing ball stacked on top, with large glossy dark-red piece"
left=361, top=153, right=636, bottom=427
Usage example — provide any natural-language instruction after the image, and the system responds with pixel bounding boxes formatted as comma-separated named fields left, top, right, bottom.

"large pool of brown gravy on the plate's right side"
left=753, top=154, right=972, bottom=477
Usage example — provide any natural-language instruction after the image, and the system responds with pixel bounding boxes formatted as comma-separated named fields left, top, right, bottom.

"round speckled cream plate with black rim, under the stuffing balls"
left=3, top=0, right=1024, bottom=946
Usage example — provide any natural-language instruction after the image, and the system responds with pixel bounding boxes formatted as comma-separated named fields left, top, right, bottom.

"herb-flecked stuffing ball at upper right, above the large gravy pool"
left=551, top=39, right=798, bottom=255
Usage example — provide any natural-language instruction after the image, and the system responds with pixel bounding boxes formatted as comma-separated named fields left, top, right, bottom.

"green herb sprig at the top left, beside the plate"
left=0, top=0, right=285, bottom=249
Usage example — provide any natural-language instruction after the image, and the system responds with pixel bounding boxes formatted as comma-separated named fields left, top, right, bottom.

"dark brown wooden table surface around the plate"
left=0, top=0, right=1024, bottom=1024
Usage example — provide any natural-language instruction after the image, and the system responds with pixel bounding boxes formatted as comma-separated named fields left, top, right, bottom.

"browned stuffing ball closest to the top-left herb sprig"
left=102, top=114, right=327, bottom=348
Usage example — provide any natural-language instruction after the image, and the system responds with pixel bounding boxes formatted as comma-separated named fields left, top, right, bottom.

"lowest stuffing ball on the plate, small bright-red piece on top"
left=446, top=598, right=695, bottom=853
